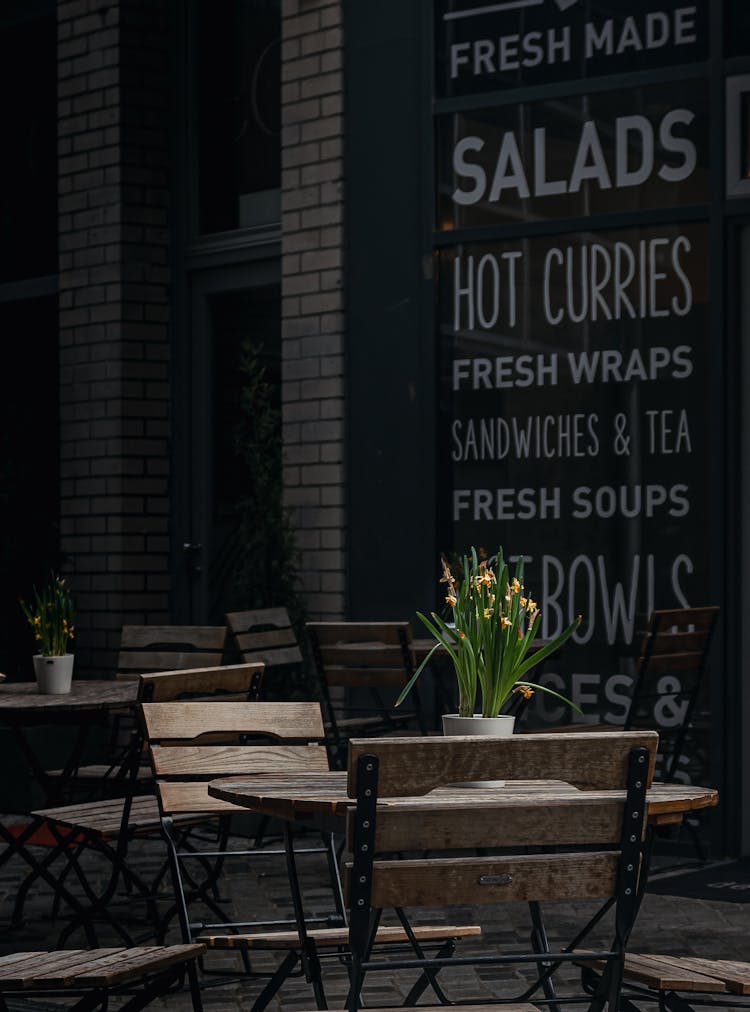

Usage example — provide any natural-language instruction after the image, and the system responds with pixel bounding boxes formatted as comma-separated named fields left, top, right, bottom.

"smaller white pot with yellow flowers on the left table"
left=20, top=573, right=74, bottom=694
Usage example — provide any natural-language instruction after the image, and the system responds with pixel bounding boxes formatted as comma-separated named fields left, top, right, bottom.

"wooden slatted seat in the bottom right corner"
left=579, top=952, right=750, bottom=999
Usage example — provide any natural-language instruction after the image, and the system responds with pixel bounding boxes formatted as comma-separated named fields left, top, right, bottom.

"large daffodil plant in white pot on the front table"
left=397, top=547, right=581, bottom=735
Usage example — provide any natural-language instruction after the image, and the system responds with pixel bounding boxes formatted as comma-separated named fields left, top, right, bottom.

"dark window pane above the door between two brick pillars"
left=195, top=0, right=281, bottom=234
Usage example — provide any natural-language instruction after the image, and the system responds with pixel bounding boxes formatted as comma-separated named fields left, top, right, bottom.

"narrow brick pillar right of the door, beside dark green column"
left=281, top=0, right=346, bottom=618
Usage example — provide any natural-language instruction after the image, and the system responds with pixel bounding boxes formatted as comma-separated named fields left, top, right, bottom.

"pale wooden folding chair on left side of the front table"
left=141, top=702, right=479, bottom=1012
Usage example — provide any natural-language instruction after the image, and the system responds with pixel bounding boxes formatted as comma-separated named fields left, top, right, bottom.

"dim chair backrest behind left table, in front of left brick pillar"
left=116, top=624, right=228, bottom=680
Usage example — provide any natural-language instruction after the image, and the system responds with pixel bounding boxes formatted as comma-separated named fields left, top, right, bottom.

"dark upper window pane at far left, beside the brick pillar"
left=0, top=13, right=57, bottom=283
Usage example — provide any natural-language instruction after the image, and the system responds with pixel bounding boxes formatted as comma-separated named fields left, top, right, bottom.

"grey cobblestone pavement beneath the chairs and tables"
left=0, top=821, right=750, bottom=1012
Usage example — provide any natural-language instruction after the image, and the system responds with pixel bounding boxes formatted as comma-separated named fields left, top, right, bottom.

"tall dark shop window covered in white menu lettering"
left=434, top=0, right=720, bottom=797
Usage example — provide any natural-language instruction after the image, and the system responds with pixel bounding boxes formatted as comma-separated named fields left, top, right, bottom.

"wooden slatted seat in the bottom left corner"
left=0, top=945, right=204, bottom=1012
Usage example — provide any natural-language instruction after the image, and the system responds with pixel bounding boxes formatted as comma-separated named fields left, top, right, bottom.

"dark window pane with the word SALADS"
left=437, top=80, right=710, bottom=229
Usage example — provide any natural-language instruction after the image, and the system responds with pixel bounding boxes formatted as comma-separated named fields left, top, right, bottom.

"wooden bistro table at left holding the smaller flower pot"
left=0, top=679, right=138, bottom=808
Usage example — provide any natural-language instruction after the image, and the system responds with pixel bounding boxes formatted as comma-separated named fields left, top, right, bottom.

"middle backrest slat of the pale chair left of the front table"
left=151, top=745, right=328, bottom=777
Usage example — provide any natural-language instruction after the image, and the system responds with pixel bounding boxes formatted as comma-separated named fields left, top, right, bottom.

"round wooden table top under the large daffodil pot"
left=209, top=770, right=719, bottom=825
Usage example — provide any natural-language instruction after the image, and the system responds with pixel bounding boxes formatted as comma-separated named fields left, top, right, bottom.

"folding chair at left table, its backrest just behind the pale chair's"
left=6, top=664, right=262, bottom=945
